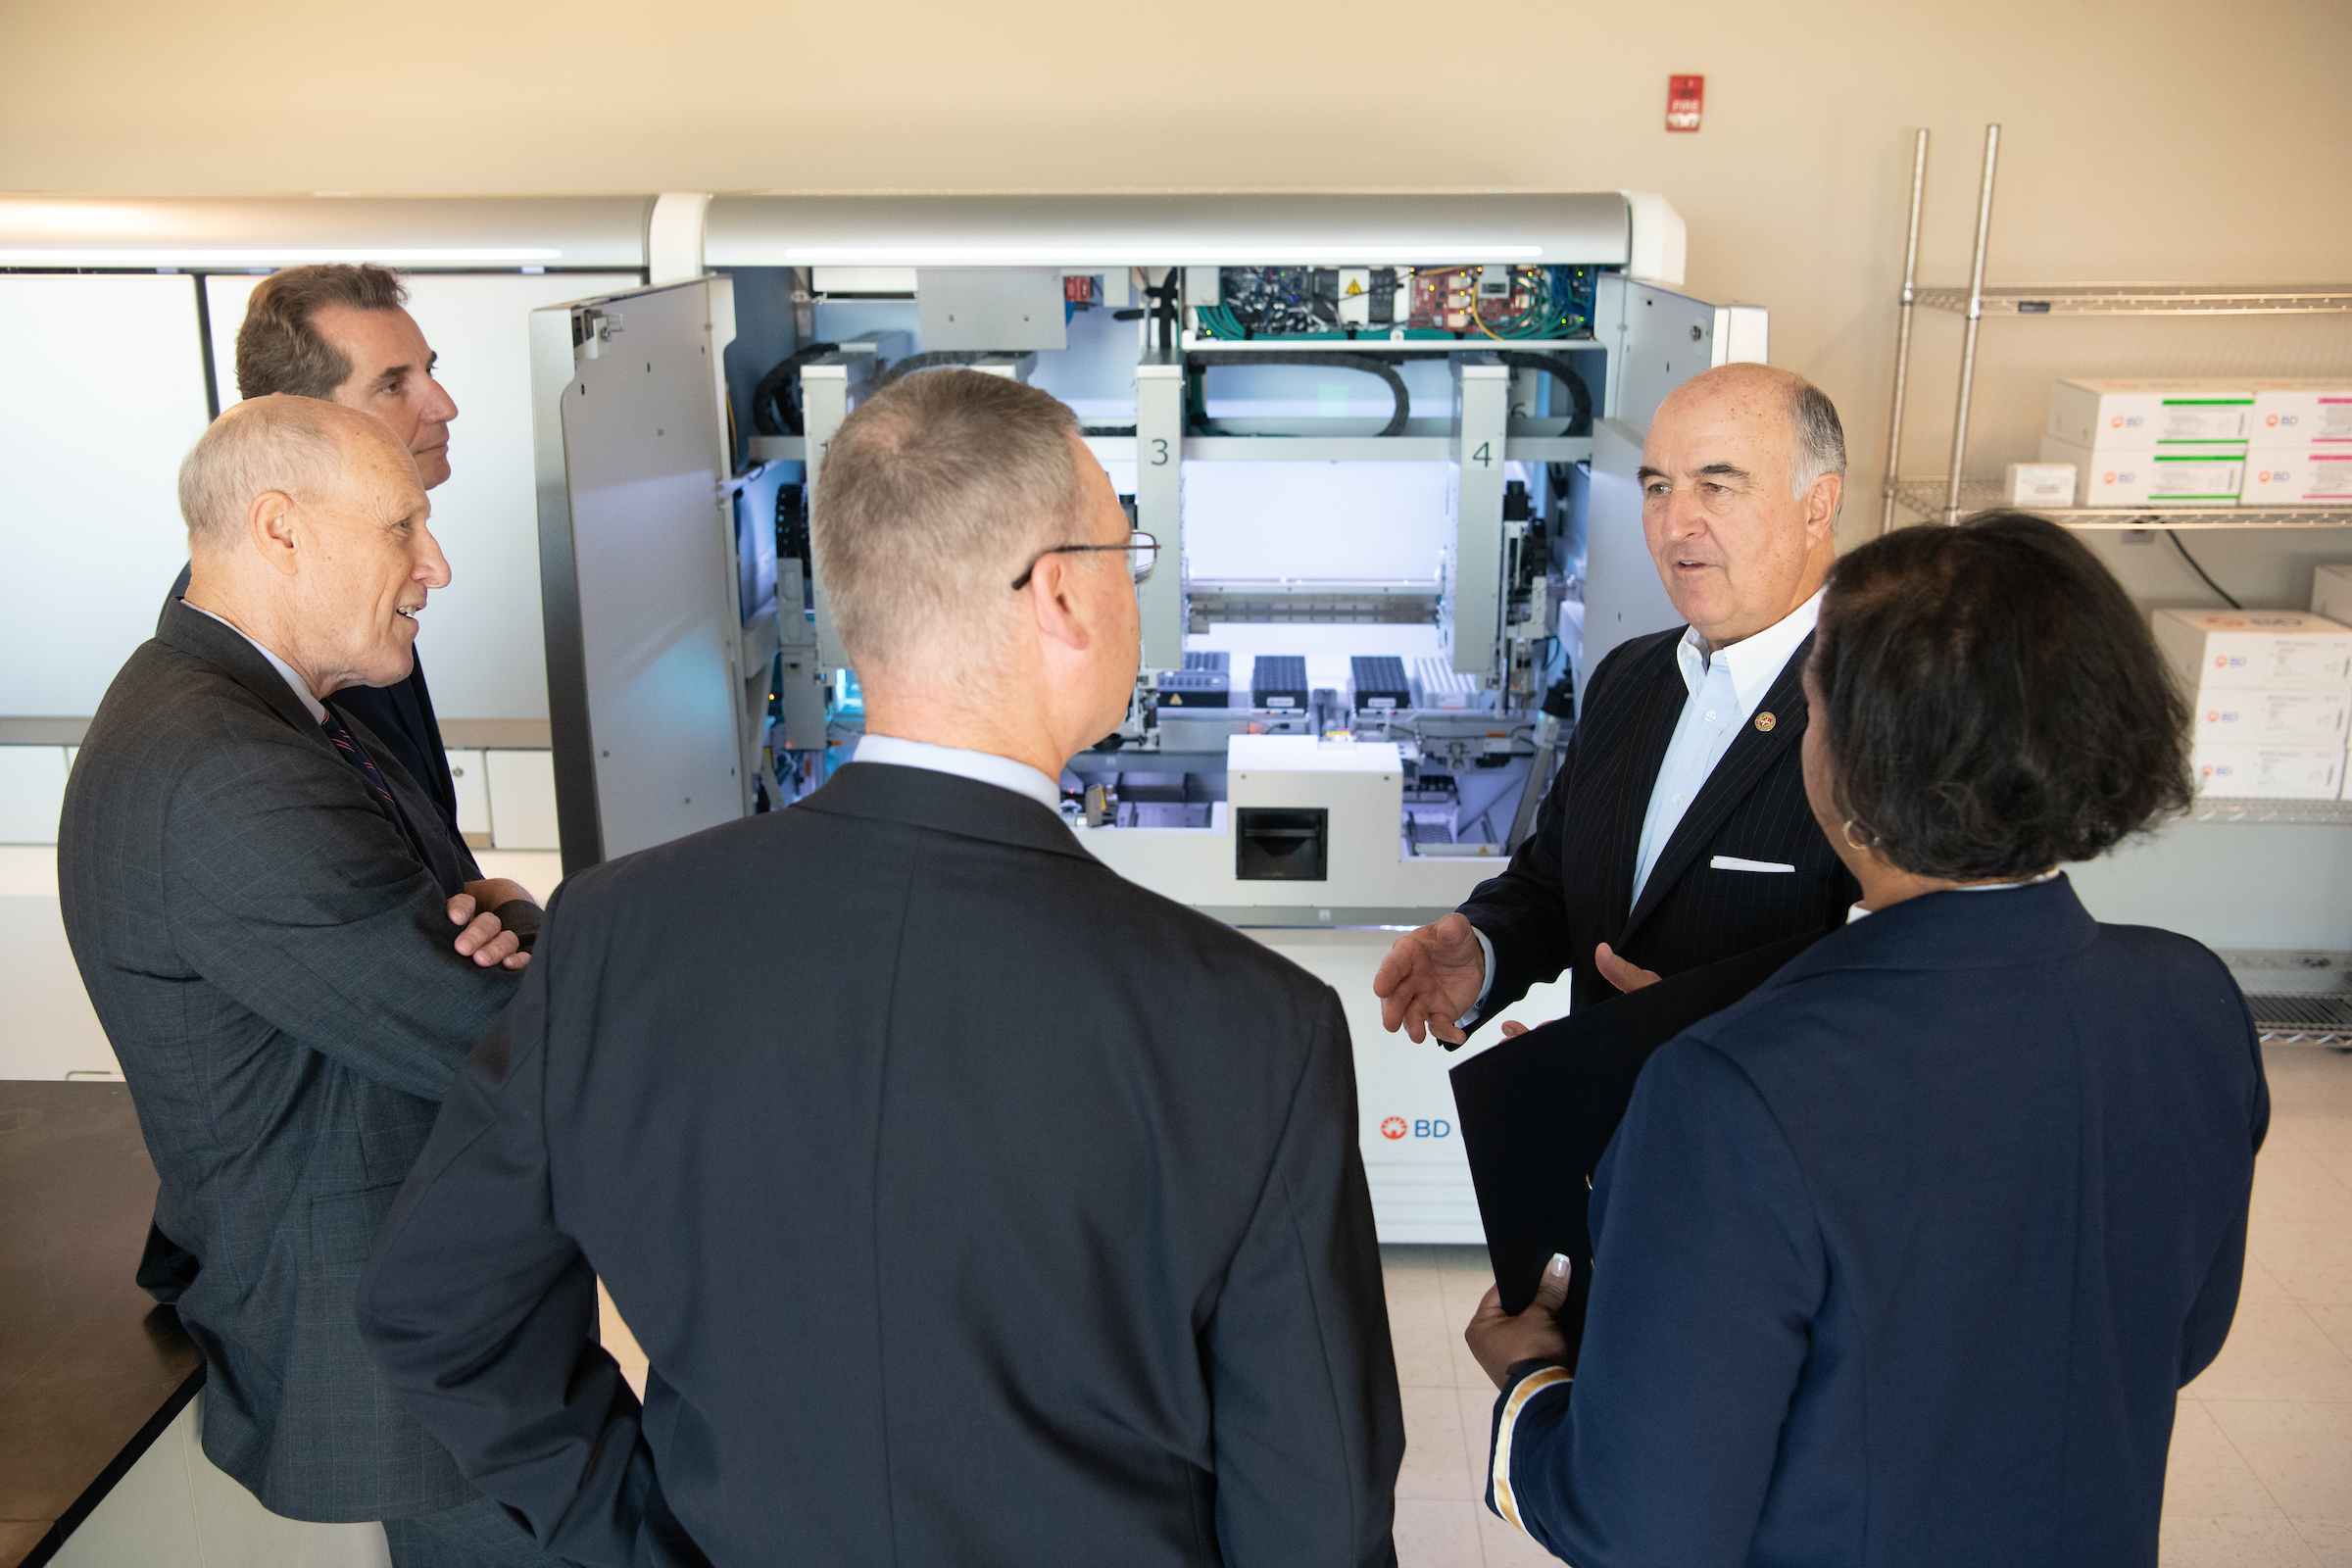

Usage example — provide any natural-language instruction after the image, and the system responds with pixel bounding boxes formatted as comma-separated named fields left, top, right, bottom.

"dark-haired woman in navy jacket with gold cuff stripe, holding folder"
left=1468, top=513, right=2270, bottom=1568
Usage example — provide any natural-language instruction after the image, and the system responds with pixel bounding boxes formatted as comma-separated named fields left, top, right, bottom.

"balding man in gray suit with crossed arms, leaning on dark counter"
left=57, top=397, right=546, bottom=1568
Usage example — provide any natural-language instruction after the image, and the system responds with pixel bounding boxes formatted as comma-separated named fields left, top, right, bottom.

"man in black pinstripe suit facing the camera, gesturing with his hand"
left=1374, top=365, right=1858, bottom=1049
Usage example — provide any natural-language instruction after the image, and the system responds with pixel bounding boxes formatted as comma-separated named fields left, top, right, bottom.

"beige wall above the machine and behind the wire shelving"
left=0, top=0, right=2352, bottom=543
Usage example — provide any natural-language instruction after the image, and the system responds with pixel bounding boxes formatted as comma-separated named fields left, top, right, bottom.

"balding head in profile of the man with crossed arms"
left=178, top=395, right=449, bottom=698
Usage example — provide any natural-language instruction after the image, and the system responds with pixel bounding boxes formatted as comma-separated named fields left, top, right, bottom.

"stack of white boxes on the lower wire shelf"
left=2154, top=609, right=2352, bottom=800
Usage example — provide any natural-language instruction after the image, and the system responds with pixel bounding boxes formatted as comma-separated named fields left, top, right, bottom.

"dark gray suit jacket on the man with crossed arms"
left=57, top=602, right=515, bottom=1521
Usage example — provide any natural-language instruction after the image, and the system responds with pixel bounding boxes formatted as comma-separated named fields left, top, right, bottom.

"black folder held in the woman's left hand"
left=1451, top=931, right=1825, bottom=1366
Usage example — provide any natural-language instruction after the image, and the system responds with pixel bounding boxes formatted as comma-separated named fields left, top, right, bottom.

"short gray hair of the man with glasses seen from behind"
left=809, top=369, right=1087, bottom=667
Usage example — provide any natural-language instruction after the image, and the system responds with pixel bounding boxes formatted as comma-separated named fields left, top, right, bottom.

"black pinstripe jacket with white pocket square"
left=1460, top=627, right=1860, bottom=1020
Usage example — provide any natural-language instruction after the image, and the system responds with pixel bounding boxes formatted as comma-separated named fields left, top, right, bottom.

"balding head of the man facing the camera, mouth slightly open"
left=1642, top=365, right=1846, bottom=647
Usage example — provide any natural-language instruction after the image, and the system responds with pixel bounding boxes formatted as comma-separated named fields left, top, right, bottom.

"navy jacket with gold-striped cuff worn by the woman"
left=1489, top=877, right=2270, bottom=1568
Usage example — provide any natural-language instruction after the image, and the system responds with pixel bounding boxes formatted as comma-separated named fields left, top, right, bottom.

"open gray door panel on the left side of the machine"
left=534, top=277, right=748, bottom=874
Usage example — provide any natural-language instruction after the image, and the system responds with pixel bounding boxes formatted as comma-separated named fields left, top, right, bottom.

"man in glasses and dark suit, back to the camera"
left=360, top=369, right=1404, bottom=1568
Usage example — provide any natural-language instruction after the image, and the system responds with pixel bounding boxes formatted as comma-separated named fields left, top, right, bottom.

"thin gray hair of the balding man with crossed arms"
left=178, top=393, right=398, bottom=550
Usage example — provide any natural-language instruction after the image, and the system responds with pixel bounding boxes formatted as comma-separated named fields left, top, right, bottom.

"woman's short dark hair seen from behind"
left=1811, top=511, right=2192, bottom=882
